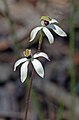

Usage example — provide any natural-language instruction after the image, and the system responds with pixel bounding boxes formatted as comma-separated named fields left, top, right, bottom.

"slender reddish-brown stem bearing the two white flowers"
left=24, top=33, right=42, bottom=120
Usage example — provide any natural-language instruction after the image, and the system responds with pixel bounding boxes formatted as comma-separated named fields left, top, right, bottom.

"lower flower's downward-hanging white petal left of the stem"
left=21, top=61, right=29, bottom=83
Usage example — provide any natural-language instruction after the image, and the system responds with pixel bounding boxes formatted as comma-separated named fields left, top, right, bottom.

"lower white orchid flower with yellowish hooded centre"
left=14, top=49, right=49, bottom=82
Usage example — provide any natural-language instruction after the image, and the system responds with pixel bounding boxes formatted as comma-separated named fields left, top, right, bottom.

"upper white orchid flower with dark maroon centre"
left=30, top=16, right=67, bottom=44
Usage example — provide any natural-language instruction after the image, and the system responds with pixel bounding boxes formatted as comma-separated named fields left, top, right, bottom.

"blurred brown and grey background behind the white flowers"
left=0, top=0, right=79, bottom=120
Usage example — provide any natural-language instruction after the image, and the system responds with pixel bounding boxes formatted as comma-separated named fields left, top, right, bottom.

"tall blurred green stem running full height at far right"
left=70, top=0, right=76, bottom=120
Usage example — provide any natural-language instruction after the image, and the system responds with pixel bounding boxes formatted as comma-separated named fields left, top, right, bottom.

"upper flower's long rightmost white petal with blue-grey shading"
left=48, top=24, right=67, bottom=37
